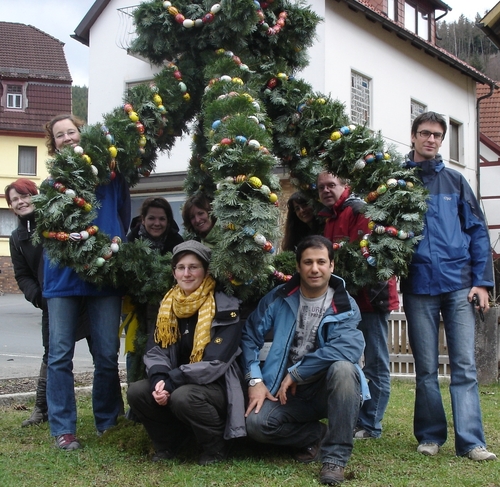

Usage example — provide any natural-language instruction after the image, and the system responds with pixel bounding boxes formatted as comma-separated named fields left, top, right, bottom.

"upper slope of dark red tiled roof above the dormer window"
left=0, top=22, right=72, bottom=82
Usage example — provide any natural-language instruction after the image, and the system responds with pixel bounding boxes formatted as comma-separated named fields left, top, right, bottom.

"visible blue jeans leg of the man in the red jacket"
left=358, top=312, right=391, bottom=438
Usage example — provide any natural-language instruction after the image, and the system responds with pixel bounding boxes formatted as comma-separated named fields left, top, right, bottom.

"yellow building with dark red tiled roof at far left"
left=0, top=22, right=72, bottom=292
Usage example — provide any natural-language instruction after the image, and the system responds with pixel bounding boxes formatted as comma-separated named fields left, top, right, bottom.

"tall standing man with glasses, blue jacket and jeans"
left=401, top=112, right=496, bottom=461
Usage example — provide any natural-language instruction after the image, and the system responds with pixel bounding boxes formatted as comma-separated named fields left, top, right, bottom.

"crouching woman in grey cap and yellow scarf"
left=127, top=240, right=246, bottom=465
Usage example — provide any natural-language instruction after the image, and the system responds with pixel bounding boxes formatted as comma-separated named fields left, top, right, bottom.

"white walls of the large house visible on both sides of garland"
left=89, top=0, right=476, bottom=189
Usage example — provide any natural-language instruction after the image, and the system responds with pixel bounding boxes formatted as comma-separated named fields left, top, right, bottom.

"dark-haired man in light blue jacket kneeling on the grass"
left=242, top=235, right=369, bottom=485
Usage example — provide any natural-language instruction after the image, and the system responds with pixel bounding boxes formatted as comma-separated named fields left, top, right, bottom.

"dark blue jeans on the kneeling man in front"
left=246, top=361, right=361, bottom=467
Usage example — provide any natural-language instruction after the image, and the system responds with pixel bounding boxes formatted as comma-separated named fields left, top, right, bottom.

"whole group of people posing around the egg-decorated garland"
left=6, top=112, right=496, bottom=485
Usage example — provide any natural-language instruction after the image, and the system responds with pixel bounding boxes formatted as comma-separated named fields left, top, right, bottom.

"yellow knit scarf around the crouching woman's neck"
left=155, top=274, right=215, bottom=363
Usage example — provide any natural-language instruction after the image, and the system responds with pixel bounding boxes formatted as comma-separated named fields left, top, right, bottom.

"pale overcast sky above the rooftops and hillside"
left=0, top=0, right=497, bottom=86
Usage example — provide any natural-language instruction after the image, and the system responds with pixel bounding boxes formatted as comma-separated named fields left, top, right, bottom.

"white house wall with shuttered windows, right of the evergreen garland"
left=305, top=0, right=477, bottom=189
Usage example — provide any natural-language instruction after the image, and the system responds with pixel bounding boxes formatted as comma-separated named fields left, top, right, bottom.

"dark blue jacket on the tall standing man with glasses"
left=401, top=153, right=493, bottom=296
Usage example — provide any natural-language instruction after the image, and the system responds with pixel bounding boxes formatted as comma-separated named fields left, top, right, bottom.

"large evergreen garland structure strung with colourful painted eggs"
left=34, top=0, right=426, bottom=302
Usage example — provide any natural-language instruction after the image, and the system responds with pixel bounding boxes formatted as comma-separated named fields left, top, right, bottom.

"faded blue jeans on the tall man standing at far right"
left=403, top=289, right=486, bottom=456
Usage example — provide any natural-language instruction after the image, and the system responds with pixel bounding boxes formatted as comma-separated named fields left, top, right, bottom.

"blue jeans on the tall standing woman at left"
left=47, top=296, right=123, bottom=436
